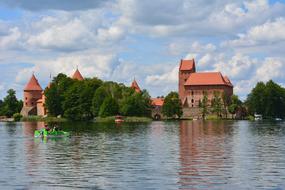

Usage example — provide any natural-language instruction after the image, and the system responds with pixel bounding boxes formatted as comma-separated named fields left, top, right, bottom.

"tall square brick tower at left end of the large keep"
left=178, top=59, right=196, bottom=102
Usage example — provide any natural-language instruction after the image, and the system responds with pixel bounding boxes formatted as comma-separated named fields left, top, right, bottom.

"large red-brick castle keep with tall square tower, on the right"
left=178, top=59, right=233, bottom=117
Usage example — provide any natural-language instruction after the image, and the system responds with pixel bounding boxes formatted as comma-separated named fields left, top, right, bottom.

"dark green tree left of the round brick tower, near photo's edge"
left=2, top=89, right=23, bottom=117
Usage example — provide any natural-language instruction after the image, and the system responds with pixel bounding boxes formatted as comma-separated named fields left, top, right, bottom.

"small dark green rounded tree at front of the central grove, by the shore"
left=99, top=96, right=119, bottom=117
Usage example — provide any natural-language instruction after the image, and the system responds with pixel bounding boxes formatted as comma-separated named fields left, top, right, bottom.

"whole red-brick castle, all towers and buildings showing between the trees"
left=21, top=59, right=233, bottom=119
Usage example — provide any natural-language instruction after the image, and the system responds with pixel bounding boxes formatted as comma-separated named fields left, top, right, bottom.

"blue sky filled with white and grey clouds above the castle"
left=0, top=0, right=285, bottom=99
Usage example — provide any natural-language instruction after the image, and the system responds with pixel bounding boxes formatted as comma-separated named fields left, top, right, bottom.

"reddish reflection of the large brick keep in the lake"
left=179, top=121, right=232, bottom=189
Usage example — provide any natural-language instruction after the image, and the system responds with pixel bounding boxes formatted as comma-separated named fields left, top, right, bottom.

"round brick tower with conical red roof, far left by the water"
left=21, top=74, right=43, bottom=116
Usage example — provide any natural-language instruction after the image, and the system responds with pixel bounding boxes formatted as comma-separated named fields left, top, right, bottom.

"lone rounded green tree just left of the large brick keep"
left=162, top=92, right=183, bottom=118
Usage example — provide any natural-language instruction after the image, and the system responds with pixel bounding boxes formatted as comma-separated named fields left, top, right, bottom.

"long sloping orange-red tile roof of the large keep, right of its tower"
left=184, top=72, right=229, bottom=86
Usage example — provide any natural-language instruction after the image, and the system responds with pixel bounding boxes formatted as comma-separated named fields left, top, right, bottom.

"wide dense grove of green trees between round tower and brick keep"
left=45, top=73, right=151, bottom=120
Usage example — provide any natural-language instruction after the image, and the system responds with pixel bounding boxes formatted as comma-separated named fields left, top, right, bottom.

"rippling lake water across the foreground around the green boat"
left=0, top=121, right=285, bottom=189
